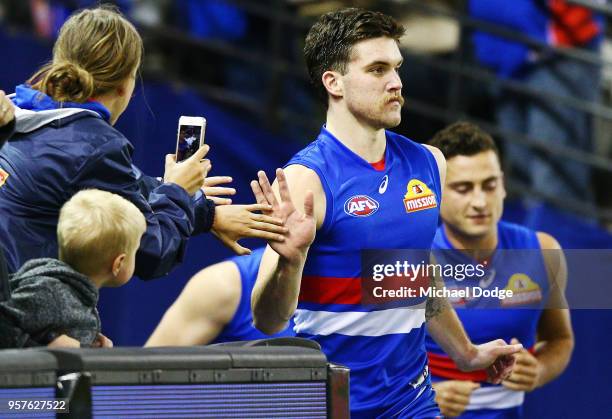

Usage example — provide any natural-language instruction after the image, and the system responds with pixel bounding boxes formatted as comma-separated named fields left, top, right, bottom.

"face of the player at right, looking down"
left=440, top=150, right=506, bottom=238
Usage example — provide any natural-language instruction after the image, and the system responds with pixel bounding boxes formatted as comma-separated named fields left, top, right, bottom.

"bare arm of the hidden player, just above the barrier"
left=145, top=262, right=242, bottom=346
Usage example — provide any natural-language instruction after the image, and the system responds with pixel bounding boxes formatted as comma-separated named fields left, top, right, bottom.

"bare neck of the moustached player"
left=326, top=106, right=387, bottom=163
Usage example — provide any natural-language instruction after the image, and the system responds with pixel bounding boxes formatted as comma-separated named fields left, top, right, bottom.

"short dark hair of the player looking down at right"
left=429, top=121, right=499, bottom=160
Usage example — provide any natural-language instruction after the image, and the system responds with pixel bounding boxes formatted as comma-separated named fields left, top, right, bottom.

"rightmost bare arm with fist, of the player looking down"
left=503, top=232, right=574, bottom=391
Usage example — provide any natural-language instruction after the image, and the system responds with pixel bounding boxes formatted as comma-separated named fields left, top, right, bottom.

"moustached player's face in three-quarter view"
left=342, top=37, right=404, bottom=129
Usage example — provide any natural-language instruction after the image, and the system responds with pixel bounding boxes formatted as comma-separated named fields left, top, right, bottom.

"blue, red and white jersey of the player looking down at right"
left=426, top=222, right=549, bottom=410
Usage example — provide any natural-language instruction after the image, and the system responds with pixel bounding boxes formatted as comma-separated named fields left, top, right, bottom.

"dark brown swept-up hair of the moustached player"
left=304, top=8, right=404, bottom=104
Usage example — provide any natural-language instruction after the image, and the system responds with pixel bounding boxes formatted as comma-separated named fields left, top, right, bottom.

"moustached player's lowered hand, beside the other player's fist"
left=462, top=339, right=523, bottom=384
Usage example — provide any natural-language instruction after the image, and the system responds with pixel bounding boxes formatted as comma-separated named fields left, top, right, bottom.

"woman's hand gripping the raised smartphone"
left=164, top=144, right=212, bottom=195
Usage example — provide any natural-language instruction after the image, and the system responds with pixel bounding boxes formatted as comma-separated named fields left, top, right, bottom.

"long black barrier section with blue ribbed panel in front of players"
left=33, top=339, right=349, bottom=418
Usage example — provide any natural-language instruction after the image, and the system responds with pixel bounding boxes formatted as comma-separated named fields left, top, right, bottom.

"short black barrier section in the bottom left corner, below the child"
left=0, top=349, right=58, bottom=418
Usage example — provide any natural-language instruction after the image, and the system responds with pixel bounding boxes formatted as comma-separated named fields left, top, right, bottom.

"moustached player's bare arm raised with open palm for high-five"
left=251, top=165, right=325, bottom=334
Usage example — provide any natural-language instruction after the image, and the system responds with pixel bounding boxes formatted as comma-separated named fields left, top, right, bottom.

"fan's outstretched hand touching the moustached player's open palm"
left=210, top=204, right=287, bottom=255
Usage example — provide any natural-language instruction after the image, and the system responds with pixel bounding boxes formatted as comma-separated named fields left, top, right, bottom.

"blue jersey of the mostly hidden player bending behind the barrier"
left=211, top=248, right=295, bottom=344
